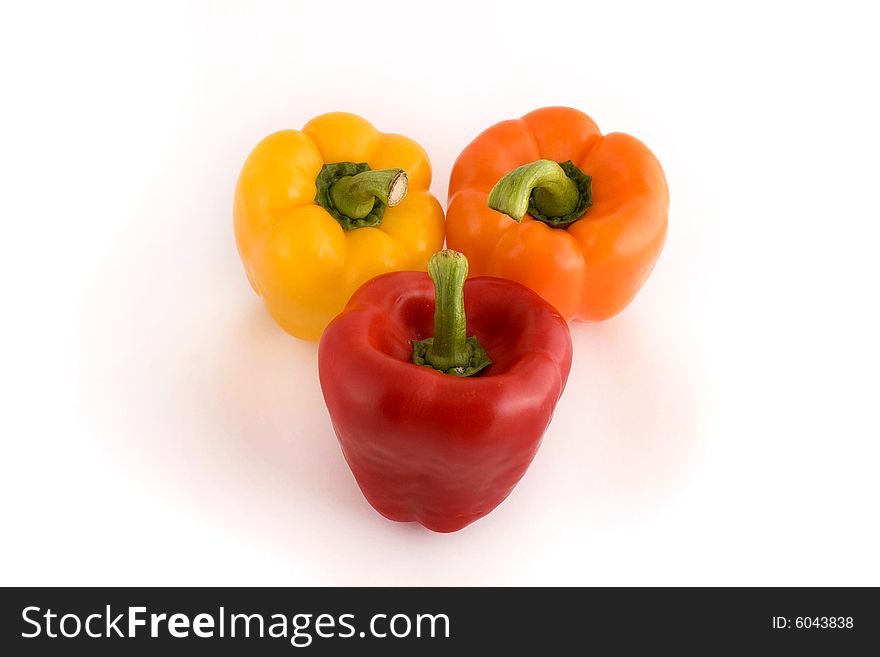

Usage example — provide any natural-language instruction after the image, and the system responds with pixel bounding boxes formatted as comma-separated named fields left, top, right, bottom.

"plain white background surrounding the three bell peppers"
left=0, top=0, right=880, bottom=585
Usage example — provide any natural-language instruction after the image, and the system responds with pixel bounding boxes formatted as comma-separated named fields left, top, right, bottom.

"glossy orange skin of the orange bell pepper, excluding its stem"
left=446, top=107, right=669, bottom=321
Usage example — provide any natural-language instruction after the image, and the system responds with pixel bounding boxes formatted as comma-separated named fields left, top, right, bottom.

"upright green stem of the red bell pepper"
left=413, top=249, right=492, bottom=376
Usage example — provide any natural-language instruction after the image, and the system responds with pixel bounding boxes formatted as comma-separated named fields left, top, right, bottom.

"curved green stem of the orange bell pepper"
left=488, top=160, right=593, bottom=228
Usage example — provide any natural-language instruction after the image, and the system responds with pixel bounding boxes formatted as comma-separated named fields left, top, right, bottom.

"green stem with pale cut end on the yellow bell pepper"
left=315, top=162, right=408, bottom=230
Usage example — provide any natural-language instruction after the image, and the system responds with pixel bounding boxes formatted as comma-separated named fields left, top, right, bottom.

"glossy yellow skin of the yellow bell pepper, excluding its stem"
left=234, top=112, right=444, bottom=340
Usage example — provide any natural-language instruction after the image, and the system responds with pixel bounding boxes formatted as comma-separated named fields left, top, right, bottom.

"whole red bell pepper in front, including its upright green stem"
left=318, top=251, right=571, bottom=532
